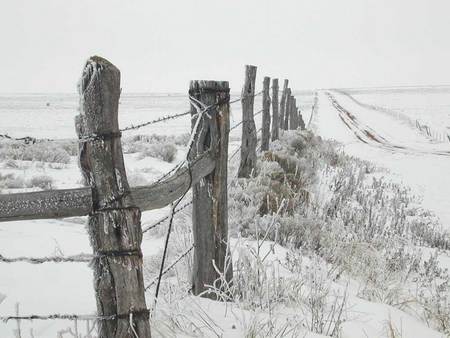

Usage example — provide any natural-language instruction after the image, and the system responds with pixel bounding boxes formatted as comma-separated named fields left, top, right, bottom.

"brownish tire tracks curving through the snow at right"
left=325, top=92, right=450, bottom=156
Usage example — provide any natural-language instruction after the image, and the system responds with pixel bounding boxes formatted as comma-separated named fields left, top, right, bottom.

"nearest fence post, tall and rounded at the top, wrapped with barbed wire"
left=76, top=56, right=151, bottom=338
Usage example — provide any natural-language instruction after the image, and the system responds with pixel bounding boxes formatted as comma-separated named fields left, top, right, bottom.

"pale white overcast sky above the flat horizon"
left=0, top=0, right=450, bottom=93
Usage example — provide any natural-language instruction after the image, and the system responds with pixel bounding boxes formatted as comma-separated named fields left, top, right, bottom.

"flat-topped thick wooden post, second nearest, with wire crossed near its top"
left=189, top=81, right=233, bottom=299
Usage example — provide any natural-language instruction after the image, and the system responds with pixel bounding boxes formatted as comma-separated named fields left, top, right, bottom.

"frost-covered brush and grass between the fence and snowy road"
left=230, top=132, right=450, bottom=334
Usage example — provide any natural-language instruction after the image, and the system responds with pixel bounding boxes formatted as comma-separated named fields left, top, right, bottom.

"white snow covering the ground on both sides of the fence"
left=0, top=90, right=450, bottom=338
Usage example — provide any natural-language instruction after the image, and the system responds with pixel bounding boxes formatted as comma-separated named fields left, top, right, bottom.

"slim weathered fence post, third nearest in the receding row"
left=238, top=65, right=258, bottom=178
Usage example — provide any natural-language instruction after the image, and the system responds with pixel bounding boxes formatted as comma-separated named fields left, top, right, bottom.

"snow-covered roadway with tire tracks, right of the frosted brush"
left=313, top=90, right=450, bottom=229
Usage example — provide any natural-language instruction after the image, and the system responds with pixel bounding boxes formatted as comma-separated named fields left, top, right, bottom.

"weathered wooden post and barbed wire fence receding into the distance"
left=0, top=56, right=305, bottom=338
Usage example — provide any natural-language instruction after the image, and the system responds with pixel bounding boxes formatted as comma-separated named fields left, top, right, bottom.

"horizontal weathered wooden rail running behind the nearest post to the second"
left=0, top=152, right=215, bottom=222
